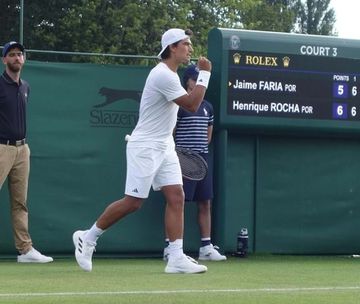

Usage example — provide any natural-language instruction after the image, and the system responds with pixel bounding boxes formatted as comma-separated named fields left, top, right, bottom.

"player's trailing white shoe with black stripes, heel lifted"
left=73, top=230, right=96, bottom=271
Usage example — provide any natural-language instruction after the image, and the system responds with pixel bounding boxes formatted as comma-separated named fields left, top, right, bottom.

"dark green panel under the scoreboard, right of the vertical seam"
left=256, top=137, right=360, bottom=254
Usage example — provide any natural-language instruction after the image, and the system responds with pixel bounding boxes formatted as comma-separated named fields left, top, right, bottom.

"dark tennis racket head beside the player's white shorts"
left=175, top=147, right=208, bottom=181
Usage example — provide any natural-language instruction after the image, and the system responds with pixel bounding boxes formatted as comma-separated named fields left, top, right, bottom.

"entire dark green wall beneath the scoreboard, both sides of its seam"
left=216, top=131, right=360, bottom=254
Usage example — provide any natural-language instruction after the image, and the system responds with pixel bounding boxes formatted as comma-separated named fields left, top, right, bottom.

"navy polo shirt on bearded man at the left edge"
left=0, top=72, right=30, bottom=140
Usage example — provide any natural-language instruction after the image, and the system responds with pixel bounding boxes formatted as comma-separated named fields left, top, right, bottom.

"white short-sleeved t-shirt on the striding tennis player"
left=129, top=62, right=187, bottom=150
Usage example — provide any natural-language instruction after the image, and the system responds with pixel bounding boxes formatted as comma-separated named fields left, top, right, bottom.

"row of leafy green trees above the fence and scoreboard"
left=0, top=0, right=335, bottom=63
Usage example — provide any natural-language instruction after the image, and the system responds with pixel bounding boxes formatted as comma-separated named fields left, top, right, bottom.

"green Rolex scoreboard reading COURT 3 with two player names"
left=208, top=29, right=360, bottom=133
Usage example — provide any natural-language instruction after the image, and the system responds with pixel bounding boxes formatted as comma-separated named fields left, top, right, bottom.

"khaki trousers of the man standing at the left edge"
left=0, top=144, right=32, bottom=253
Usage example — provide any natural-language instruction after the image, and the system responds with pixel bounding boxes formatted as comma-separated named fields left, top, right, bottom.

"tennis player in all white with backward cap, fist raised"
left=73, top=28, right=211, bottom=273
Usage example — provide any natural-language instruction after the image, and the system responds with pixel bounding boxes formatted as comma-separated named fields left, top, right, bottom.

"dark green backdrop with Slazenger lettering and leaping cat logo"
left=0, top=61, right=199, bottom=254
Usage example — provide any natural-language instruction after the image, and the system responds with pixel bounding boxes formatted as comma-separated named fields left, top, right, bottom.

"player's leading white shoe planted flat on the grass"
left=165, top=254, right=207, bottom=273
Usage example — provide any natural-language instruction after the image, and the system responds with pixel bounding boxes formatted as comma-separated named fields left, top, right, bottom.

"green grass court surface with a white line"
left=0, top=254, right=360, bottom=304
